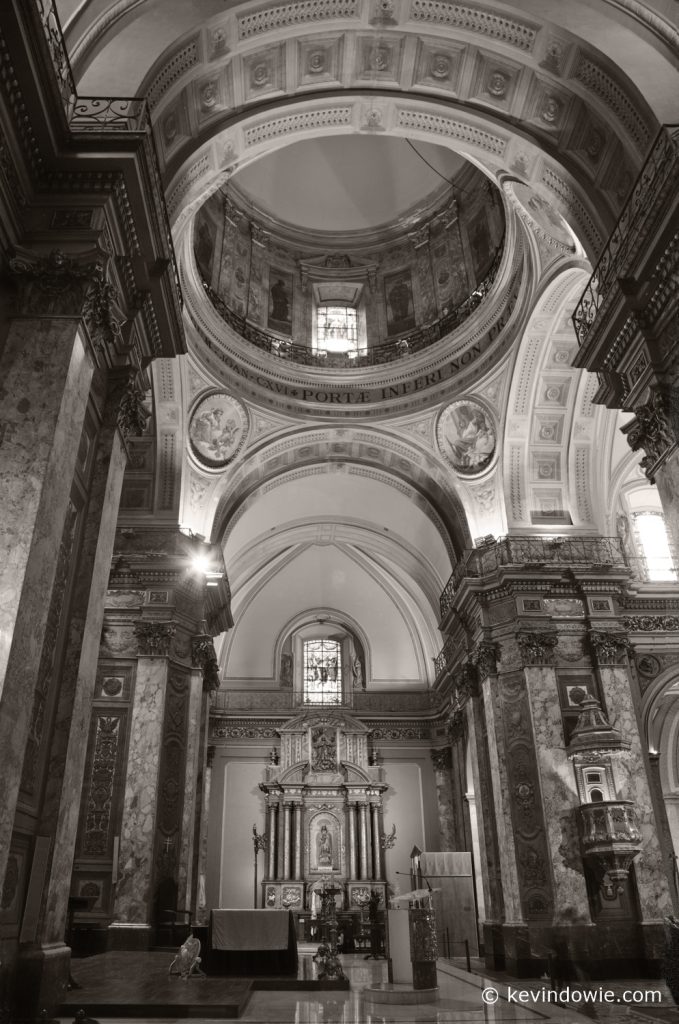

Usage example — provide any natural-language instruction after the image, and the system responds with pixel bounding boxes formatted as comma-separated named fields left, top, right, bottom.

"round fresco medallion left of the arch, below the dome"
left=188, top=391, right=248, bottom=469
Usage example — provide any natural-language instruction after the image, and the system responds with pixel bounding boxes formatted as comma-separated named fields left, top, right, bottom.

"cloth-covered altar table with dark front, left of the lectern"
left=205, top=907, right=297, bottom=977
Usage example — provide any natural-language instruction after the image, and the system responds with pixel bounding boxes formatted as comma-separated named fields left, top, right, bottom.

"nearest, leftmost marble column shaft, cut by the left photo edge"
left=0, top=317, right=93, bottom=880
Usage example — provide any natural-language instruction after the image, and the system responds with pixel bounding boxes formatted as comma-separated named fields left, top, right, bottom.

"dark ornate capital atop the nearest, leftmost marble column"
left=9, top=249, right=102, bottom=316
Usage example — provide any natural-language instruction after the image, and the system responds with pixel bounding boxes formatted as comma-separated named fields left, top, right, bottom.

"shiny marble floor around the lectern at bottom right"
left=58, top=956, right=679, bottom=1024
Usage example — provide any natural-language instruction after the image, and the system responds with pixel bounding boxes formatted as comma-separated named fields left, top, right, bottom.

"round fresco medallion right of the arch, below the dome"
left=436, top=398, right=496, bottom=476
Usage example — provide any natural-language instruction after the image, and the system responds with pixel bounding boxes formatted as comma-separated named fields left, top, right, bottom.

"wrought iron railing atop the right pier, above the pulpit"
left=440, top=537, right=626, bottom=618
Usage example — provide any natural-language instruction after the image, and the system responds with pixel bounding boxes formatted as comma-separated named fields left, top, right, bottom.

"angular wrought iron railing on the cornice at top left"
left=34, top=0, right=182, bottom=304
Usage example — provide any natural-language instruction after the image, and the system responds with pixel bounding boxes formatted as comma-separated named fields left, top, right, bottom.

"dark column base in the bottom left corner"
left=13, top=942, right=71, bottom=1019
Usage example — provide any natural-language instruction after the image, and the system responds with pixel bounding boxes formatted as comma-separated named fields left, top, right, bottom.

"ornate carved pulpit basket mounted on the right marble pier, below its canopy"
left=578, top=800, right=641, bottom=888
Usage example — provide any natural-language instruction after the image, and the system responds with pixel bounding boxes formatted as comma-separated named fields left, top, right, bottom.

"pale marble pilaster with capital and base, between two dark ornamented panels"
left=109, top=623, right=174, bottom=949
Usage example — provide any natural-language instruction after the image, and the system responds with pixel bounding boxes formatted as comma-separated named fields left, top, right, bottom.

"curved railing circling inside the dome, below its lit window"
left=203, top=237, right=505, bottom=370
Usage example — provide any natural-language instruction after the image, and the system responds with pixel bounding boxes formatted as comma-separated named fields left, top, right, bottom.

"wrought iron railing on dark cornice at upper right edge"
left=572, top=125, right=679, bottom=345
